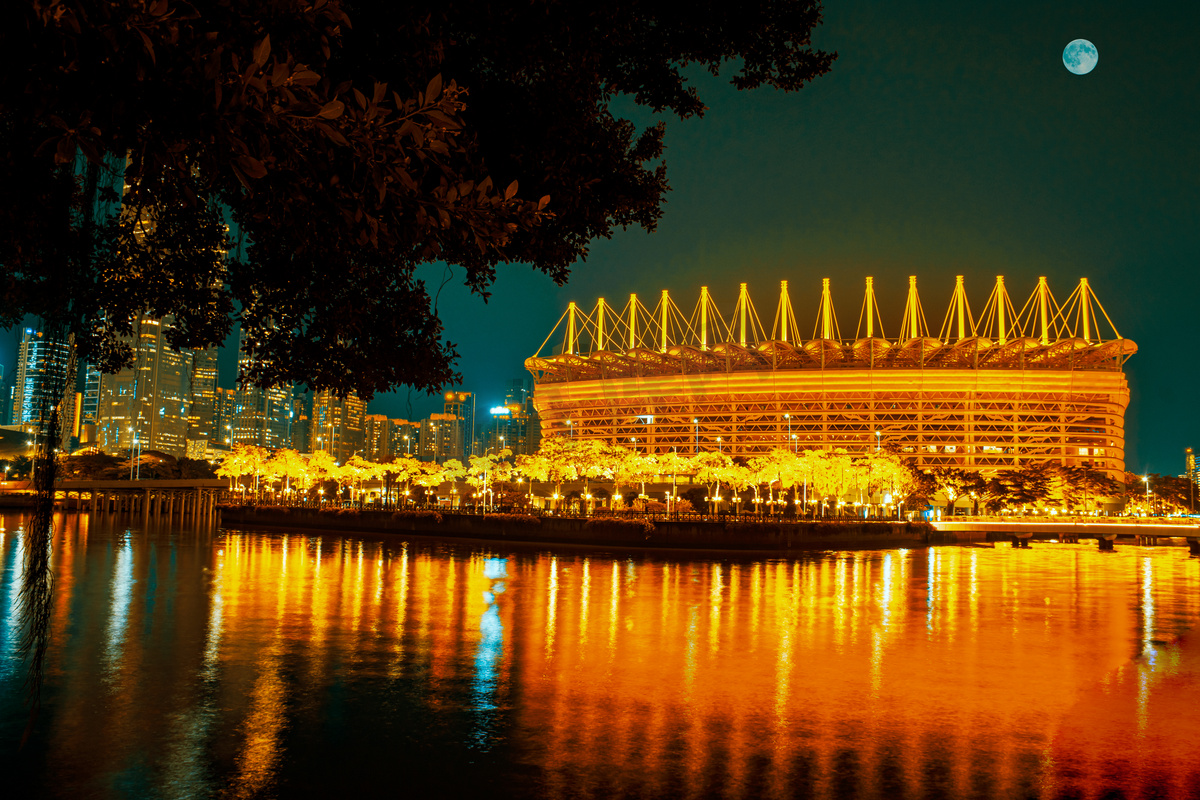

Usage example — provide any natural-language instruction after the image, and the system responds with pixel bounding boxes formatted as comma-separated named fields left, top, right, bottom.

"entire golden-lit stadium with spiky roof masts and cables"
left=526, top=276, right=1138, bottom=476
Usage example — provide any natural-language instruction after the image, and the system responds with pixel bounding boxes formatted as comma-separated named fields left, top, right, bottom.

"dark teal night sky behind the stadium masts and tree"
left=0, top=0, right=1200, bottom=474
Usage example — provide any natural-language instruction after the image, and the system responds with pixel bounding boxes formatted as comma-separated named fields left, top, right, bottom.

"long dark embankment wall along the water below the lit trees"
left=221, top=505, right=958, bottom=551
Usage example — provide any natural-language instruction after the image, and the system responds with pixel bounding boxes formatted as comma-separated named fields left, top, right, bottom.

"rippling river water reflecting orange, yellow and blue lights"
left=0, top=516, right=1200, bottom=799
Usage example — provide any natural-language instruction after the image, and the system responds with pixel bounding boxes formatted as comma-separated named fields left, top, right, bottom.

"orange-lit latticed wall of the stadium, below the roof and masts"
left=536, top=369, right=1129, bottom=475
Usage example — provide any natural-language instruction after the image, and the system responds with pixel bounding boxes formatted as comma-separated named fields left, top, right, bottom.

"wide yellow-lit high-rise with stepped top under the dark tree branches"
left=96, top=315, right=192, bottom=457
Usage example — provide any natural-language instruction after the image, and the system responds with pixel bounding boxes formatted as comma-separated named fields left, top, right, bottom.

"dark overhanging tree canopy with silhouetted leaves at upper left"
left=0, top=0, right=834, bottom=398
